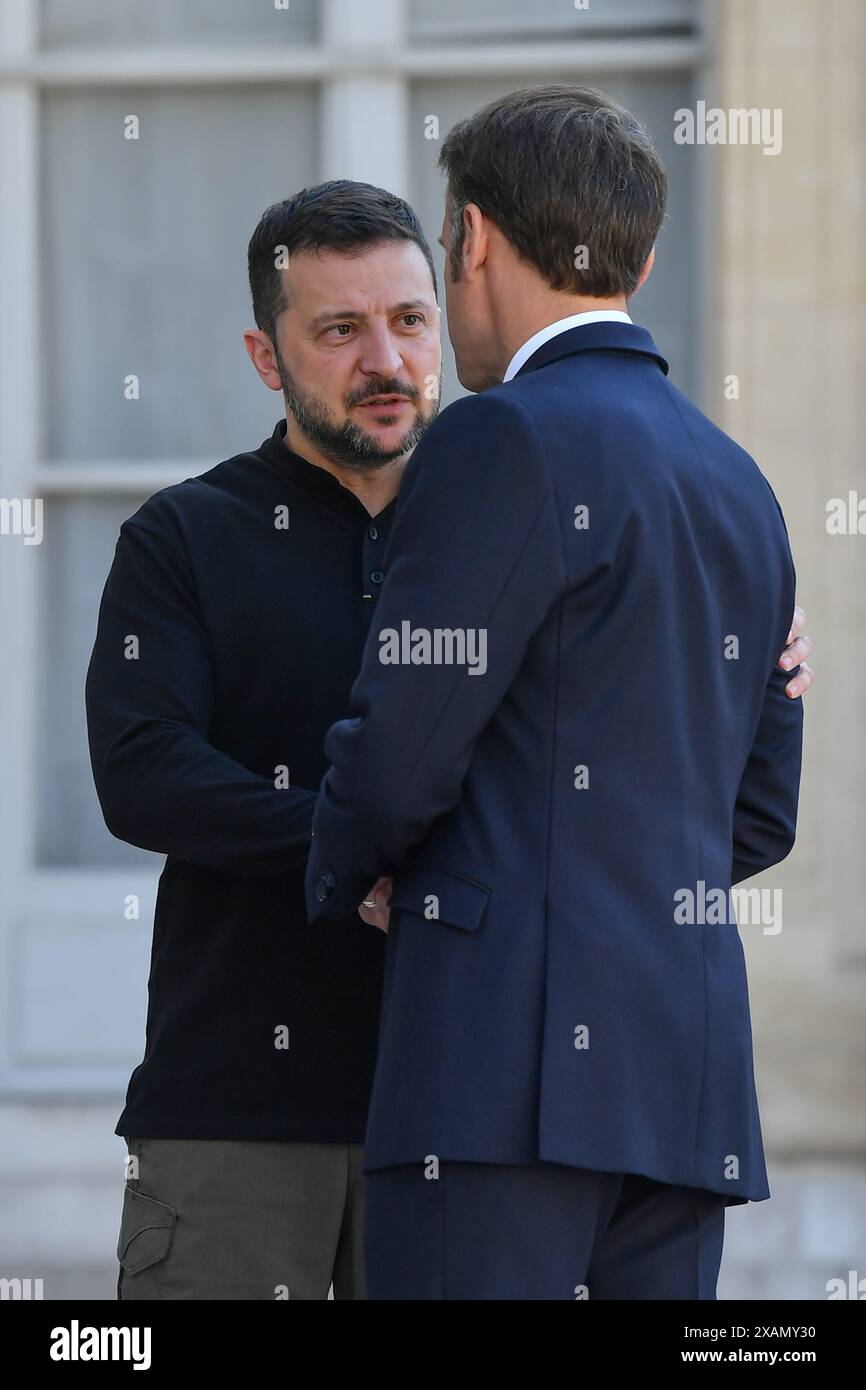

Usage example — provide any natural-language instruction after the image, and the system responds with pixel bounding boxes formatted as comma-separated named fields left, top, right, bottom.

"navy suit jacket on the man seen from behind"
left=307, top=322, right=802, bottom=1204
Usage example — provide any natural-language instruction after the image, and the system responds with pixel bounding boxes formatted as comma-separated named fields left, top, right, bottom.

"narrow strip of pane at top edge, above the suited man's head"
left=409, top=0, right=695, bottom=39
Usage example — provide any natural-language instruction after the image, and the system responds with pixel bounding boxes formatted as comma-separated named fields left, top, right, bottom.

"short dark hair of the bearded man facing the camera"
left=247, top=179, right=439, bottom=345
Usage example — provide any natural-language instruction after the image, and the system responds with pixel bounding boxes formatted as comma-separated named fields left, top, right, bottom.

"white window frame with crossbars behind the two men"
left=0, top=0, right=712, bottom=1097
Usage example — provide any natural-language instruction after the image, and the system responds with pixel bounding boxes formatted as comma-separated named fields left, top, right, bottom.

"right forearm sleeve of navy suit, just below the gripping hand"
left=731, top=658, right=803, bottom=884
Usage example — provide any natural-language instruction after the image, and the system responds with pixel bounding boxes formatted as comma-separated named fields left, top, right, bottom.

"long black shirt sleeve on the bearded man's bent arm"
left=85, top=495, right=316, bottom=874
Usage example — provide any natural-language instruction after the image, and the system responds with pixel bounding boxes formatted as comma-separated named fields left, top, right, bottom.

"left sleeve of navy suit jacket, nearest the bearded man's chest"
left=307, top=396, right=564, bottom=922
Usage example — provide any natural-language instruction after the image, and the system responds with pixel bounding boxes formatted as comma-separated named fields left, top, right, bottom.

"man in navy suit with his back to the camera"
left=306, top=86, right=802, bottom=1298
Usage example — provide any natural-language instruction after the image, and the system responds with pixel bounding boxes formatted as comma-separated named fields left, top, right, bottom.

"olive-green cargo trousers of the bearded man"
left=117, top=1138, right=364, bottom=1301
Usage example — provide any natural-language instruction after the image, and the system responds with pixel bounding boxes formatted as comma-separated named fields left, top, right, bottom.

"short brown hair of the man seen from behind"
left=439, top=83, right=667, bottom=299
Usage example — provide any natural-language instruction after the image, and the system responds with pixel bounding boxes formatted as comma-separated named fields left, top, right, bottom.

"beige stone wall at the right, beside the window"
left=698, top=0, right=866, bottom=1162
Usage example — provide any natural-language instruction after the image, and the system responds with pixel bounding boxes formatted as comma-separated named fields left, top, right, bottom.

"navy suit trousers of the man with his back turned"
left=364, top=1162, right=724, bottom=1300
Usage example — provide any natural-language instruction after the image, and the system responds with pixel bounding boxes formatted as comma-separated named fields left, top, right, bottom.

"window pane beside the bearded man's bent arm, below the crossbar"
left=35, top=496, right=157, bottom=866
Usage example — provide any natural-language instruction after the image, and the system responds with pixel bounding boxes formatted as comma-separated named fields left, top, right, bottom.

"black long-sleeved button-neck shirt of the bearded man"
left=86, top=420, right=396, bottom=1143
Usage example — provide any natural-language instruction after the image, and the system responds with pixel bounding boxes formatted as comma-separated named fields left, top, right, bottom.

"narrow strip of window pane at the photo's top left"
left=42, top=0, right=318, bottom=47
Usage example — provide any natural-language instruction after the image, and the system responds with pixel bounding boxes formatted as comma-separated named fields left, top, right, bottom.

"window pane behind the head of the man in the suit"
left=410, top=72, right=699, bottom=400
